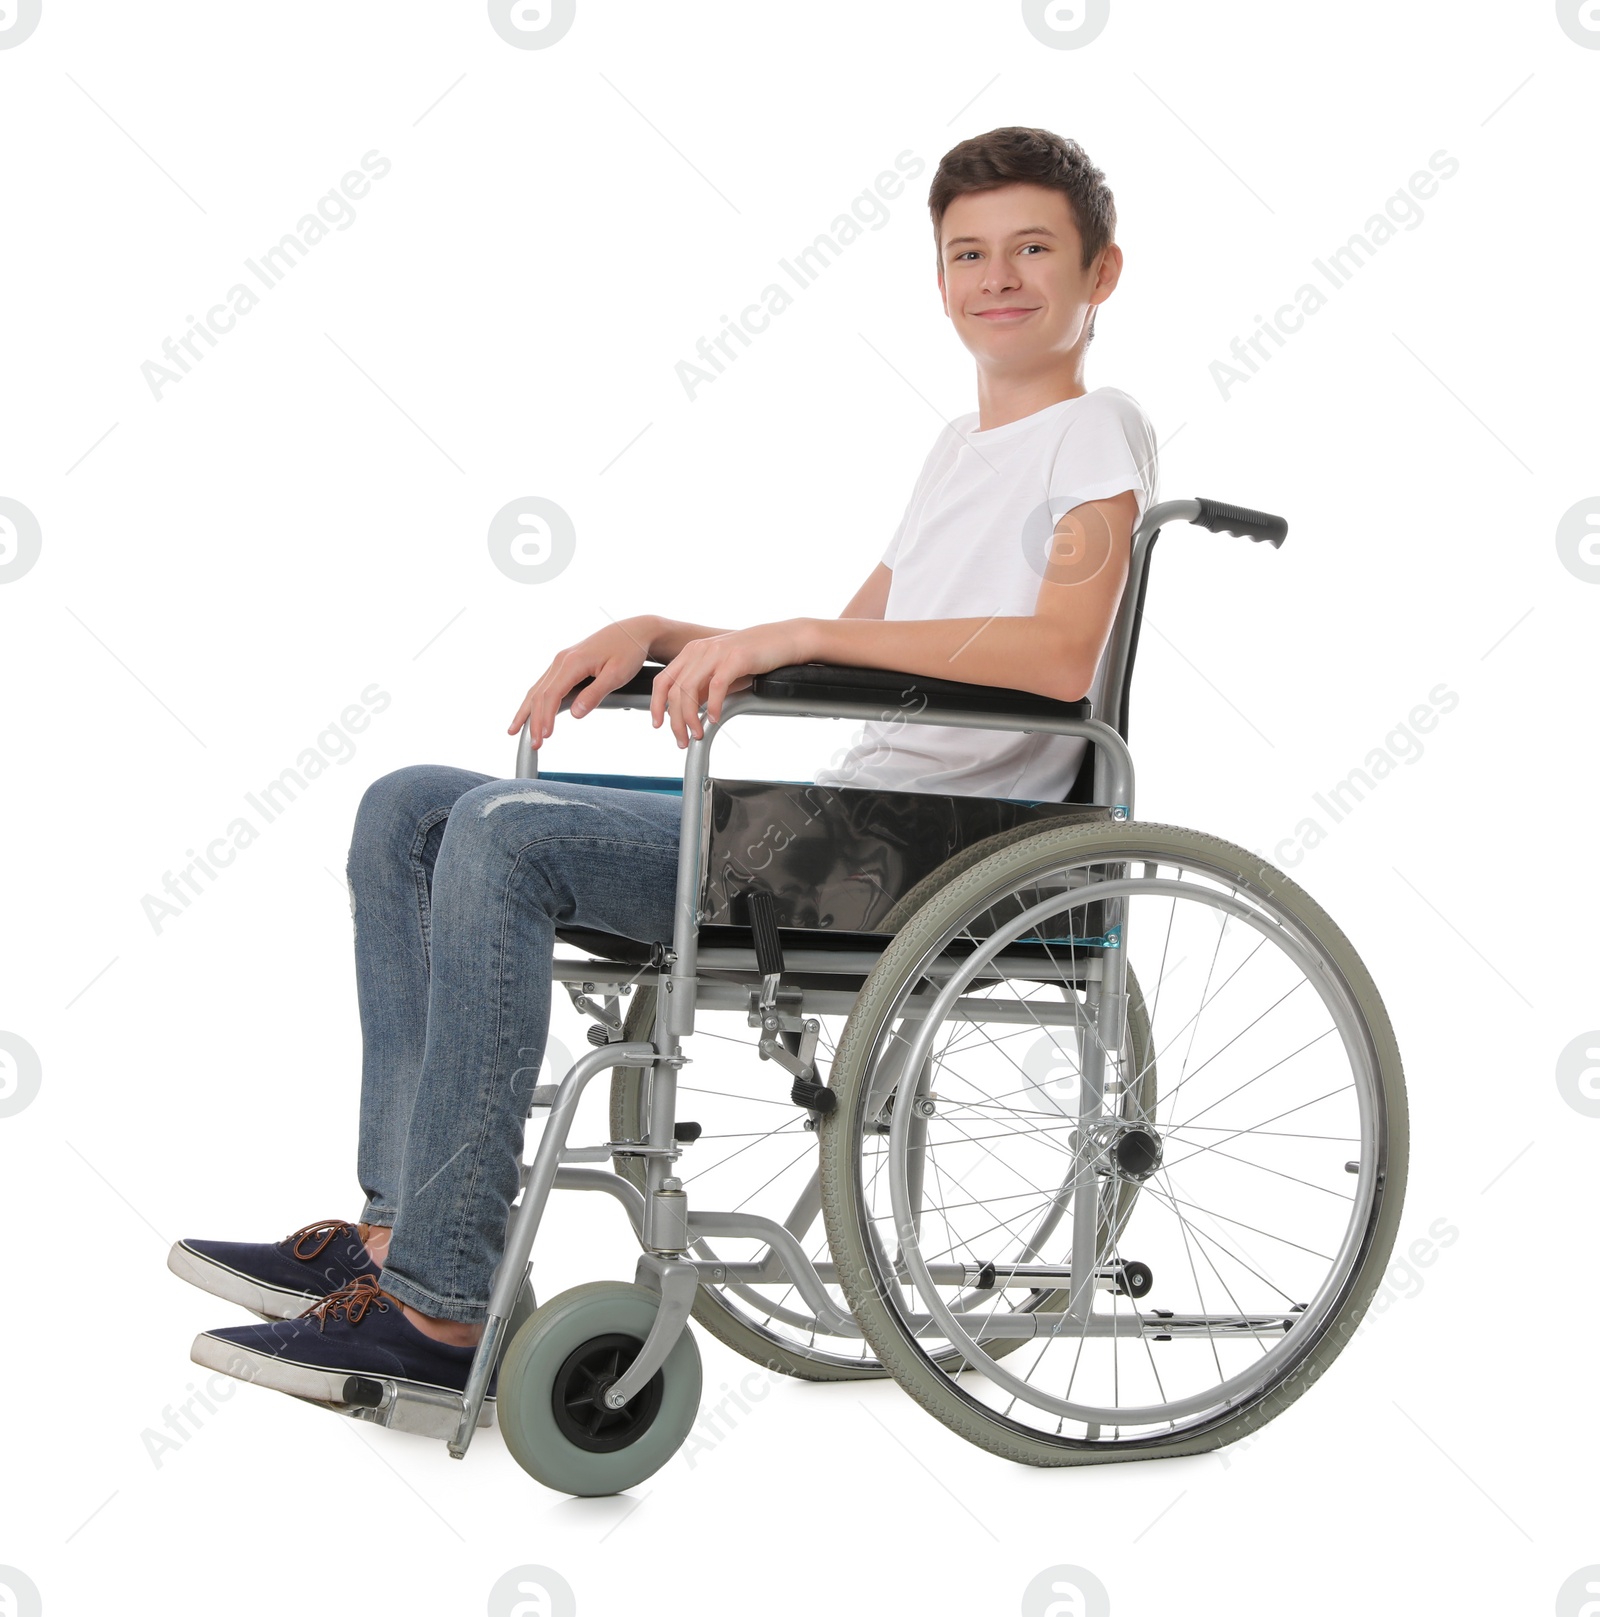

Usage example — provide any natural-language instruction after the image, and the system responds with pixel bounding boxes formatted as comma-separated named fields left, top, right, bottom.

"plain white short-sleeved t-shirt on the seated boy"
left=815, top=388, right=1158, bottom=802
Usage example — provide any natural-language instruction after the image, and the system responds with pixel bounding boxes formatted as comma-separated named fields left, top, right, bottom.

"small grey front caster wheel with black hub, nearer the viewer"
left=497, top=1281, right=701, bottom=1496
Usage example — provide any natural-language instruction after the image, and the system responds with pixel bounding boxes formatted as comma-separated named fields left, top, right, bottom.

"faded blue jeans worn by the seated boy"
left=346, top=765, right=683, bottom=1319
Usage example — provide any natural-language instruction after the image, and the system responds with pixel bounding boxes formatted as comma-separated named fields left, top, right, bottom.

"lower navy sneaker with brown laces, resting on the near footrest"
left=189, top=1274, right=495, bottom=1404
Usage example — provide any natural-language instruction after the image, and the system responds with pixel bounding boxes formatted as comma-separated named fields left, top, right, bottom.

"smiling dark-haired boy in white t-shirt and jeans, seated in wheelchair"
left=168, top=128, right=1157, bottom=1402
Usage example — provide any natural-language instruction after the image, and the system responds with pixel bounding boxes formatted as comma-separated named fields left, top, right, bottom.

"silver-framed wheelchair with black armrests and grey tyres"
left=331, top=500, right=1407, bottom=1494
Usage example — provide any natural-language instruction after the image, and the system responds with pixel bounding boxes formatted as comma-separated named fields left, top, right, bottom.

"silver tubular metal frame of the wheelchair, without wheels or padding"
left=427, top=500, right=1285, bottom=1459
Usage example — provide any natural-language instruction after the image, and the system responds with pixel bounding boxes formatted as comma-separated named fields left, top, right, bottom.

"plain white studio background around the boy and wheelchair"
left=0, top=0, right=1600, bottom=1617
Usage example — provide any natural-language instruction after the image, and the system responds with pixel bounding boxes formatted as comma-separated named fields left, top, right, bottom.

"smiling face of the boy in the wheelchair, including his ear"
left=938, top=184, right=1123, bottom=369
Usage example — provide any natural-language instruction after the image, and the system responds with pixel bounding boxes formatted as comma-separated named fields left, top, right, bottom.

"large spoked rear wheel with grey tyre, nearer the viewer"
left=820, top=823, right=1406, bottom=1465
